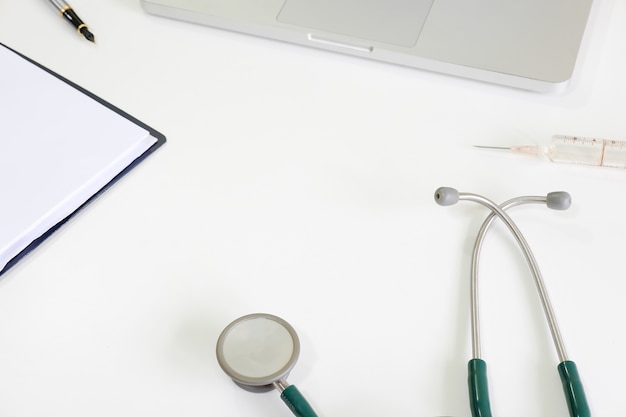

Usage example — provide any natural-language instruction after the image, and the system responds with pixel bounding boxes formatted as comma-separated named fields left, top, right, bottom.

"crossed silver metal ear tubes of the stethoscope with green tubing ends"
left=458, top=193, right=591, bottom=417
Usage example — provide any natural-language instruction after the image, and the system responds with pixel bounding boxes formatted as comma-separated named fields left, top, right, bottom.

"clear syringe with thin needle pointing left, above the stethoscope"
left=477, top=135, right=626, bottom=168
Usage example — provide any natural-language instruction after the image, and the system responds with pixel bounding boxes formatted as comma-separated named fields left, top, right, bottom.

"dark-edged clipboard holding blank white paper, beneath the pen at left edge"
left=0, top=43, right=166, bottom=277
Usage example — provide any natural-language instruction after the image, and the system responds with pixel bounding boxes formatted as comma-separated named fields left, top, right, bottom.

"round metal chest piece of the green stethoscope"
left=216, top=313, right=300, bottom=392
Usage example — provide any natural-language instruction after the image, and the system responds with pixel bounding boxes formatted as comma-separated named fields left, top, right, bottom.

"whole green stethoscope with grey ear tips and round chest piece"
left=216, top=187, right=591, bottom=417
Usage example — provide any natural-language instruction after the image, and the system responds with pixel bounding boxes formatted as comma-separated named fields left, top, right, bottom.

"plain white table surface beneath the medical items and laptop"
left=0, top=0, right=626, bottom=417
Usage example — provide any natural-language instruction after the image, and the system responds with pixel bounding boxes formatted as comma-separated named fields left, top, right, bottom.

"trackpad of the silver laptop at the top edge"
left=277, top=0, right=434, bottom=47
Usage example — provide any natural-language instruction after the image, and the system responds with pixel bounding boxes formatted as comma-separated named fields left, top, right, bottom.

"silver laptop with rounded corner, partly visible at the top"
left=141, top=0, right=592, bottom=92
